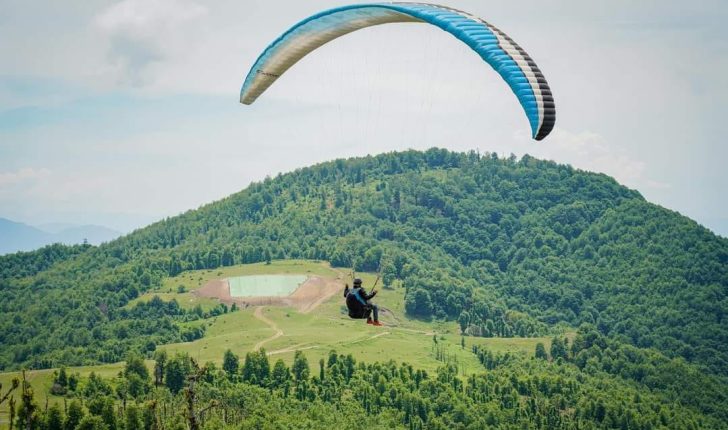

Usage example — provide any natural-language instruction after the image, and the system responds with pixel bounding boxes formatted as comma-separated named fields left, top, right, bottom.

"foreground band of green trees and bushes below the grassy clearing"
left=11, top=330, right=728, bottom=430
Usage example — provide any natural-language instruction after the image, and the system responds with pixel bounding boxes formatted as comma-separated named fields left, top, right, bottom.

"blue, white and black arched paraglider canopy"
left=240, top=2, right=556, bottom=140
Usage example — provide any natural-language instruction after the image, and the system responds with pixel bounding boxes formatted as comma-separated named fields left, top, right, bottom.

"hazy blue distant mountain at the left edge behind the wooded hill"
left=0, top=218, right=121, bottom=254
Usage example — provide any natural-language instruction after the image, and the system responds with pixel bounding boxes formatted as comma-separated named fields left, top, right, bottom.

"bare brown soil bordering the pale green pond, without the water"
left=193, top=276, right=344, bottom=313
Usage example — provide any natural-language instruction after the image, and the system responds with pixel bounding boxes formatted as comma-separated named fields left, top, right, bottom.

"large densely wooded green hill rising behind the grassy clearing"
left=0, top=149, right=728, bottom=377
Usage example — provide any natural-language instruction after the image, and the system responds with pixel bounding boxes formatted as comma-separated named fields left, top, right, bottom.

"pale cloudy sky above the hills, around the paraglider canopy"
left=0, top=0, right=728, bottom=237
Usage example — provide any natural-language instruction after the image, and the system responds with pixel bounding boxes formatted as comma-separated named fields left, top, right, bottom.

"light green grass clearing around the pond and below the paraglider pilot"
left=0, top=261, right=564, bottom=423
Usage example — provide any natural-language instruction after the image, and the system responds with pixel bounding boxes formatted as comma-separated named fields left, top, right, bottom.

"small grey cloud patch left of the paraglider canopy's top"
left=95, top=0, right=207, bottom=86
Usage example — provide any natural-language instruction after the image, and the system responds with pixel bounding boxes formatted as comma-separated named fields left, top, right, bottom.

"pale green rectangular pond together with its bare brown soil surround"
left=193, top=275, right=344, bottom=313
